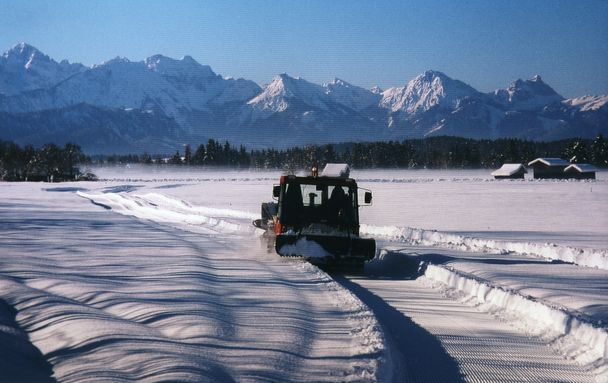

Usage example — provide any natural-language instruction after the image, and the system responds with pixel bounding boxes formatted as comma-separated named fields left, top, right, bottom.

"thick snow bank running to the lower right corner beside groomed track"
left=424, top=265, right=608, bottom=382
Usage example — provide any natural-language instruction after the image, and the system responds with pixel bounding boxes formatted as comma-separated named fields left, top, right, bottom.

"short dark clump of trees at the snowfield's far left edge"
left=0, top=140, right=95, bottom=182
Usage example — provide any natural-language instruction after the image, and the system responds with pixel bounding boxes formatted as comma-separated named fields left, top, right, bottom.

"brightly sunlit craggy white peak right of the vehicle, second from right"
left=380, top=70, right=479, bottom=114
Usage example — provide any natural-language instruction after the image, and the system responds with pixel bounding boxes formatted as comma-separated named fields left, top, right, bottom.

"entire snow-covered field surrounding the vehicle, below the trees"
left=0, top=168, right=608, bottom=382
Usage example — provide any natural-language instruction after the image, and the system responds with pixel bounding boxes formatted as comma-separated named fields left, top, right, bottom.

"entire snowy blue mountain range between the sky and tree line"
left=0, top=43, right=608, bottom=153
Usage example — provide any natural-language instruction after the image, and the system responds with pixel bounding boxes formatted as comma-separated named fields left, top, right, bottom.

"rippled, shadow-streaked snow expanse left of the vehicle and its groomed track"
left=0, top=183, right=390, bottom=382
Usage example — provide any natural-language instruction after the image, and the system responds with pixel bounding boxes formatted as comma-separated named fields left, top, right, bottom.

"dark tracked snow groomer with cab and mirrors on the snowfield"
left=253, top=164, right=376, bottom=266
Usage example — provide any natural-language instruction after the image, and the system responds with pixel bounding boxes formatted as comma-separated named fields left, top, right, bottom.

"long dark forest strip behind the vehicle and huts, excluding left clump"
left=96, top=135, right=608, bottom=169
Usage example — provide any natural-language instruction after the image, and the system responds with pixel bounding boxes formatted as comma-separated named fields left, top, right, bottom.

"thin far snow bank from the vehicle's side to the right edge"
left=361, top=225, right=608, bottom=270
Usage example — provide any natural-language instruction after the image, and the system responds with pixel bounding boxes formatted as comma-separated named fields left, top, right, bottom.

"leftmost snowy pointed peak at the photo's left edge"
left=0, top=43, right=86, bottom=96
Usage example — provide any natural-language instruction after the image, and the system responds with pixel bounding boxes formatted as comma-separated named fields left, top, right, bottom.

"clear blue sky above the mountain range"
left=0, top=0, right=608, bottom=97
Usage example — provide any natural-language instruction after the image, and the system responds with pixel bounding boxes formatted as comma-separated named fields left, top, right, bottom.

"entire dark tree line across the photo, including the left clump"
left=0, top=134, right=608, bottom=181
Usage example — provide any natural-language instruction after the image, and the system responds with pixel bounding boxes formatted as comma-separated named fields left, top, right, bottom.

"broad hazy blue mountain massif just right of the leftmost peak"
left=0, top=49, right=260, bottom=123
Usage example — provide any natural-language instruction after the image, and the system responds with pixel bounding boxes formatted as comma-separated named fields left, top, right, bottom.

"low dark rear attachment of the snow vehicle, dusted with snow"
left=275, top=234, right=376, bottom=266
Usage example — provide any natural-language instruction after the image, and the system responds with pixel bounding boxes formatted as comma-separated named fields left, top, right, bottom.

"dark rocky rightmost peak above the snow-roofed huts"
left=493, top=75, right=564, bottom=110
